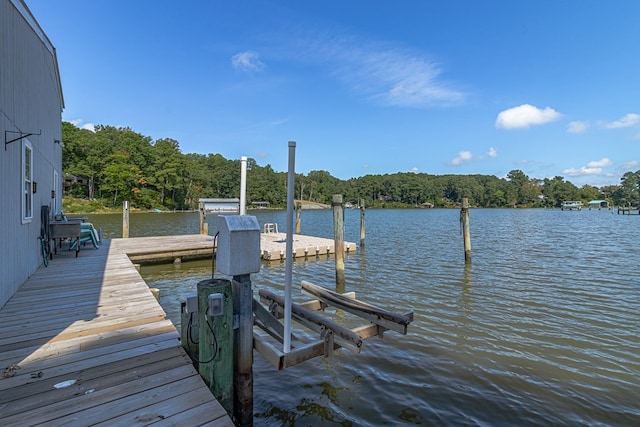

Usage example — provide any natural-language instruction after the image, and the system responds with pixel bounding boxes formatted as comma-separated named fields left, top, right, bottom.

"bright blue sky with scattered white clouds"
left=26, top=0, right=640, bottom=186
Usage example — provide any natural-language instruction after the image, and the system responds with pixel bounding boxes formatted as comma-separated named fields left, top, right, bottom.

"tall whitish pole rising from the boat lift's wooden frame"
left=282, top=141, right=296, bottom=353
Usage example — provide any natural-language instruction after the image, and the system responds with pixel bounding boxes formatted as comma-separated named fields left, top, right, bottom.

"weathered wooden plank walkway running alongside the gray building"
left=0, top=236, right=233, bottom=426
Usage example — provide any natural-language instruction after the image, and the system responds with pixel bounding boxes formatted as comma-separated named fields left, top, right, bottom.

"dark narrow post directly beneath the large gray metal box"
left=231, top=274, right=253, bottom=427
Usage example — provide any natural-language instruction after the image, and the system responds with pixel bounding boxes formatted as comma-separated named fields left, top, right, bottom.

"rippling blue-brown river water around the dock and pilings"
left=90, top=209, right=640, bottom=426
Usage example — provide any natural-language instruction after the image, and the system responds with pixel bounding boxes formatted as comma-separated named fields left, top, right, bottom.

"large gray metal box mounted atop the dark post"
left=216, top=215, right=260, bottom=276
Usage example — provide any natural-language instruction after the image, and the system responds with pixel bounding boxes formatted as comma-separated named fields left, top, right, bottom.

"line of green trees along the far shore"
left=62, top=122, right=640, bottom=210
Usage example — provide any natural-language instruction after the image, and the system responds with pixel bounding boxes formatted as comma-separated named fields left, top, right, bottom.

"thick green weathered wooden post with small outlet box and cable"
left=197, top=279, right=233, bottom=415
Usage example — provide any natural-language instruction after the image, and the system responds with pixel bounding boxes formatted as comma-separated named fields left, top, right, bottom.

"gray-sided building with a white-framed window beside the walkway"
left=0, top=0, right=64, bottom=307
